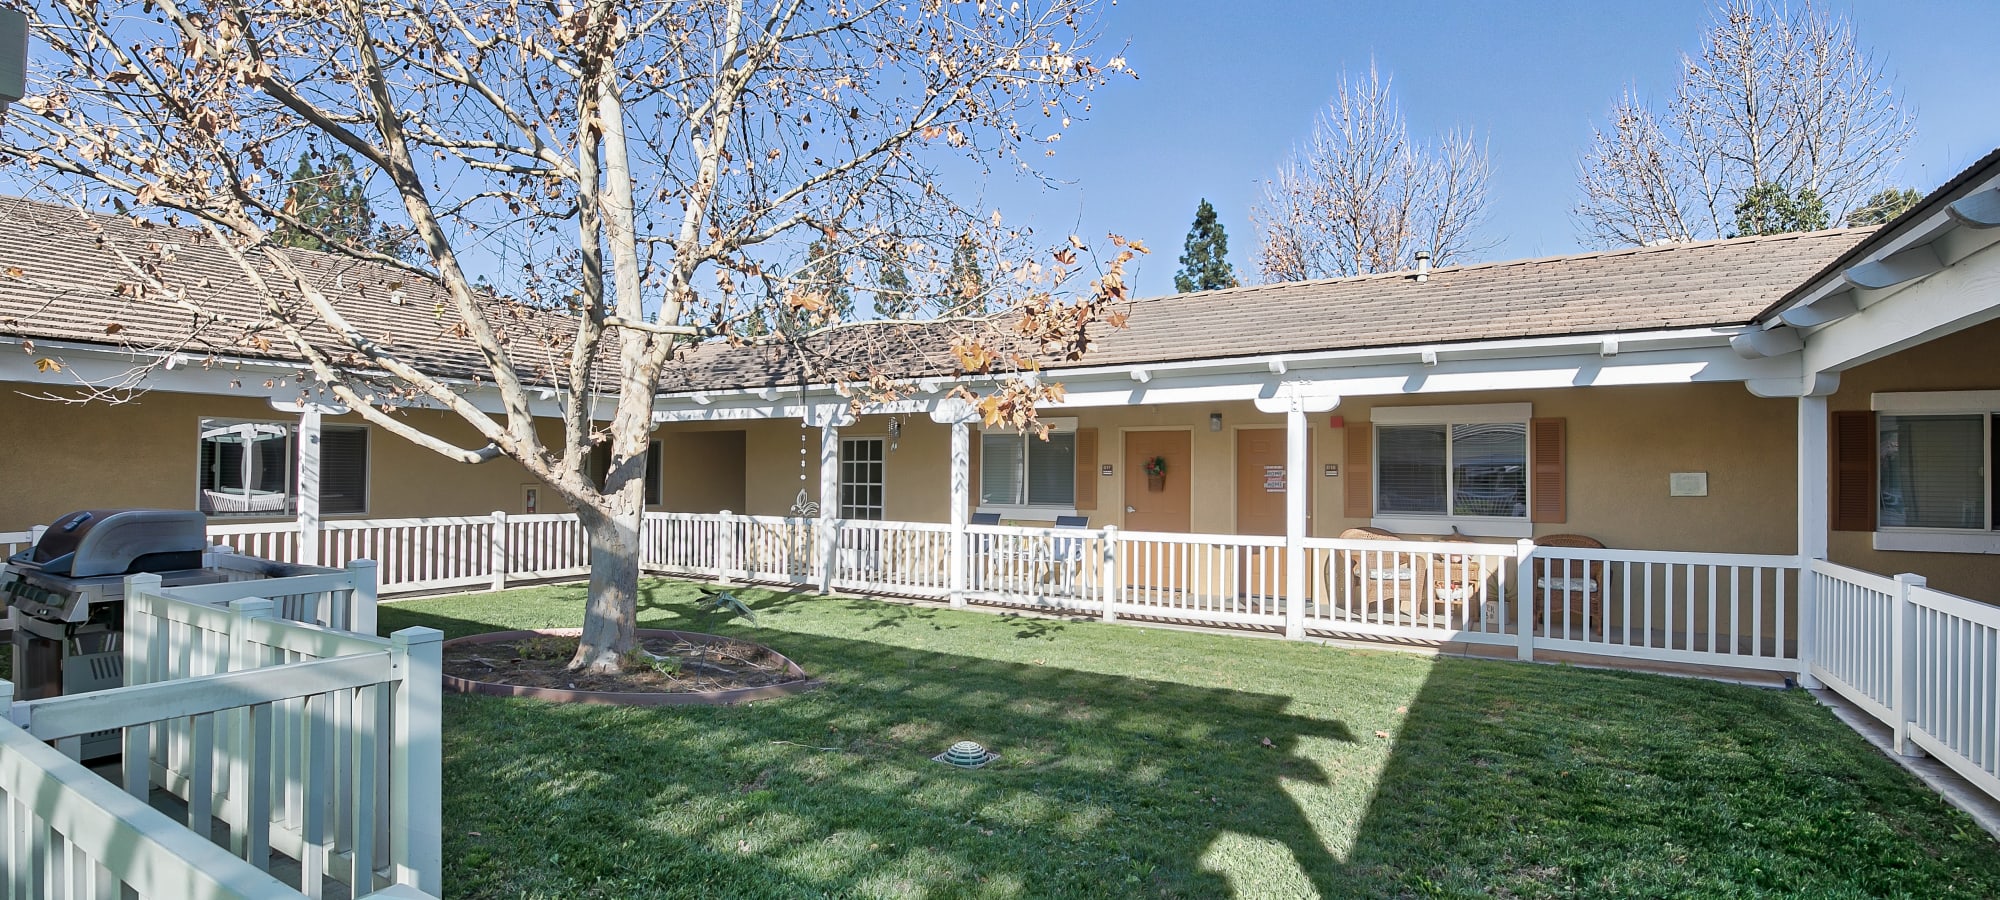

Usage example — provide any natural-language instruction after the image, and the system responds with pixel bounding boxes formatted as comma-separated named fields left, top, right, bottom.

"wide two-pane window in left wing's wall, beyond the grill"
left=196, top=418, right=368, bottom=516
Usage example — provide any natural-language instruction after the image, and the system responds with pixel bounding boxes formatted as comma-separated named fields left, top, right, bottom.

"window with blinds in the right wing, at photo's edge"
left=1876, top=414, right=1996, bottom=530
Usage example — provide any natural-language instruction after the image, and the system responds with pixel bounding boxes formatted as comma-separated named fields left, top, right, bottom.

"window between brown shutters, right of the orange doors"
left=1374, top=404, right=1528, bottom=520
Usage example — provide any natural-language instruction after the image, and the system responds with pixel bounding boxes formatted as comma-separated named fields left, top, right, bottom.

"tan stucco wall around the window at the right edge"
left=1826, top=322, right=2000, bottom=604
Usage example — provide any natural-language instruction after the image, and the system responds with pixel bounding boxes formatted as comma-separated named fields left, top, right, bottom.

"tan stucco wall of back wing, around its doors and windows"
left=662, top=384, right=1796, bottom=554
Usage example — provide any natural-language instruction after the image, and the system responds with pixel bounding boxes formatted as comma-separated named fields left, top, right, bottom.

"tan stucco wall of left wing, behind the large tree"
left=0, top=382, right=752, bottom=532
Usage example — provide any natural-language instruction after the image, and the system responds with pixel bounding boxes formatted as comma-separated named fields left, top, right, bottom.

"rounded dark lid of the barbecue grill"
left=14, top=510, right=208, bottom=578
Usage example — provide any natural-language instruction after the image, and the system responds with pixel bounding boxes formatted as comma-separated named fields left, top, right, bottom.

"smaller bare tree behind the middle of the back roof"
left=1250, top=66, right=1490, bottom=282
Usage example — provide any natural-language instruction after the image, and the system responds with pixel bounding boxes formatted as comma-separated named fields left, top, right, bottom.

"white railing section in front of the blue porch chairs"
left=960, top=526, right=1104, bottom=610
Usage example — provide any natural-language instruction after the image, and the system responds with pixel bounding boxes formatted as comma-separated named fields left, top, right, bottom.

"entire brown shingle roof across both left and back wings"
left=0, top=198, right=1870, bottom=392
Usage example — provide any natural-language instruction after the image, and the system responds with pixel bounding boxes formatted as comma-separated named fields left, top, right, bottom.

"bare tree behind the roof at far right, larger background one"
left=1574, top=0, right=1916, bottom=246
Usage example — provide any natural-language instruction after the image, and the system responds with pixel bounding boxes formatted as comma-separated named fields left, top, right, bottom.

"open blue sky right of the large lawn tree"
left=972, top=0, right=2000, bottom=296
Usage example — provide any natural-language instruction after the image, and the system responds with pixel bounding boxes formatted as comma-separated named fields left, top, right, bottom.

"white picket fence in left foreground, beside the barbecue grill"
left=0, top=554, right=442, bottom=898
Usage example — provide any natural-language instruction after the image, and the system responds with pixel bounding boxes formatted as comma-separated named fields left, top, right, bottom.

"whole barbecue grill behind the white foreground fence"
left=0, top=510, right=330, bottom=758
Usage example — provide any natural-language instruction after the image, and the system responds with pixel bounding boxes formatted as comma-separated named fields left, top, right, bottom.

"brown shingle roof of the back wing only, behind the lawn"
left=664, top=228, right=1872, bottom=390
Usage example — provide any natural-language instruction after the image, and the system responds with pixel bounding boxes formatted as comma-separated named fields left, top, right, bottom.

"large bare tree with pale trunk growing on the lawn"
left=0, top=0, right=1134, bottom=670
